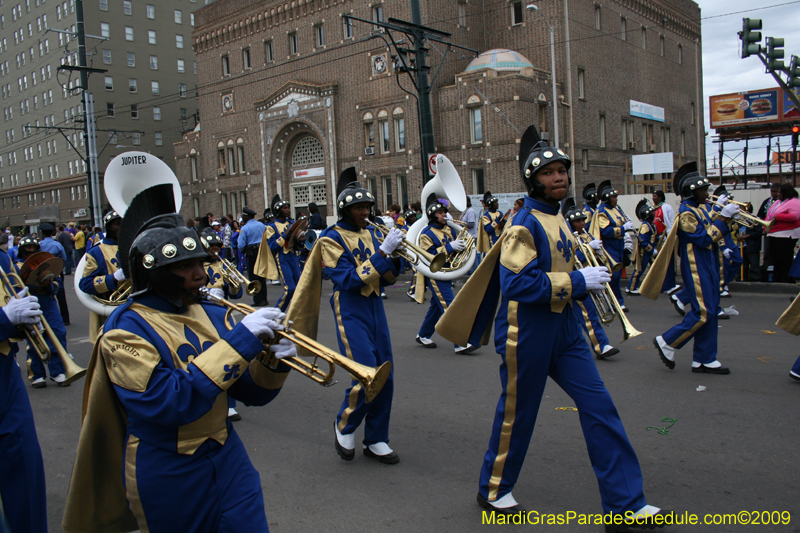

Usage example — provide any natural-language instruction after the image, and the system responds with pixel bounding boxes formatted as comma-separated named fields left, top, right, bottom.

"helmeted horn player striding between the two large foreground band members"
left=318, top=167, right=403, bottom=464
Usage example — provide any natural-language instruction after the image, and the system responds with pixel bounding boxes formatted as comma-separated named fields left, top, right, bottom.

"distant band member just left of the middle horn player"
left=264, top=194, right=305, bottom=311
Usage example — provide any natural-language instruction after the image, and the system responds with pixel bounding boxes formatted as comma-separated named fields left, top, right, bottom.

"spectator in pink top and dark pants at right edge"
left=767, top=183, right=800, bottom=283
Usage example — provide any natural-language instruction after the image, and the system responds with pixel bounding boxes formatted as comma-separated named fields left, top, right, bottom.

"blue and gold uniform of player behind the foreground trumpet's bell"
left=315, top=220, right=398, bottom=445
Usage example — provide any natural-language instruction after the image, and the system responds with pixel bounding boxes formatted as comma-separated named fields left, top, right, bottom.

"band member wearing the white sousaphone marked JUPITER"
left=79, top=211, right=125, bottom=343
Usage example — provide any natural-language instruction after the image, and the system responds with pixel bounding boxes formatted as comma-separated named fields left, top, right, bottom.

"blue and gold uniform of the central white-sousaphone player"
left=417, top=206, right=458, bottom=348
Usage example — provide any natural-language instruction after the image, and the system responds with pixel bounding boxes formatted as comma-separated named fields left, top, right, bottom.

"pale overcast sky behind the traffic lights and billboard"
left=695, top=0, right=800, bottom=166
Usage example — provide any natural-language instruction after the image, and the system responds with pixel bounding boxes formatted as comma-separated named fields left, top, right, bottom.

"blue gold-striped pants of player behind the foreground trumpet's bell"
left=331, top=291, right=394, bottom=445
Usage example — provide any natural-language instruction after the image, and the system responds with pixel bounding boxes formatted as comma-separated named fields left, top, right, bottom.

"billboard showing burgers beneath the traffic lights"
left=708, top=87, right=800, bottom=129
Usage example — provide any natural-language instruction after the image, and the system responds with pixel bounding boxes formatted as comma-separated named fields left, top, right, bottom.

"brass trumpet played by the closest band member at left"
left=200, top=287, right=392, bottom=402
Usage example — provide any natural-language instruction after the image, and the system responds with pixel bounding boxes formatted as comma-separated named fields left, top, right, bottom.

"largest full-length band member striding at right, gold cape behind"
left=437, top=126, right=668, bottom=531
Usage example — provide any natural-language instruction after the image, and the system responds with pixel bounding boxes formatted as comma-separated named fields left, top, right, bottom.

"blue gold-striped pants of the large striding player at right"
left=480, top=302, right=646, bottom=513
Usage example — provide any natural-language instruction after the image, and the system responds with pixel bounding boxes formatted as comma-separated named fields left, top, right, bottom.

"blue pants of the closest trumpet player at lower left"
left=123, top=430, right=269, bottom=533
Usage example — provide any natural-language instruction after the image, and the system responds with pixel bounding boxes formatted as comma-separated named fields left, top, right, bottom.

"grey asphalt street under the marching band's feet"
left=18, top=276, right=800, bottom=533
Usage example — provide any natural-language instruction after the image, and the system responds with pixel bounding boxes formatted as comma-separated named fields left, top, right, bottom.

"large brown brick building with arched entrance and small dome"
left=175, top=0, right=704, bottom=221
